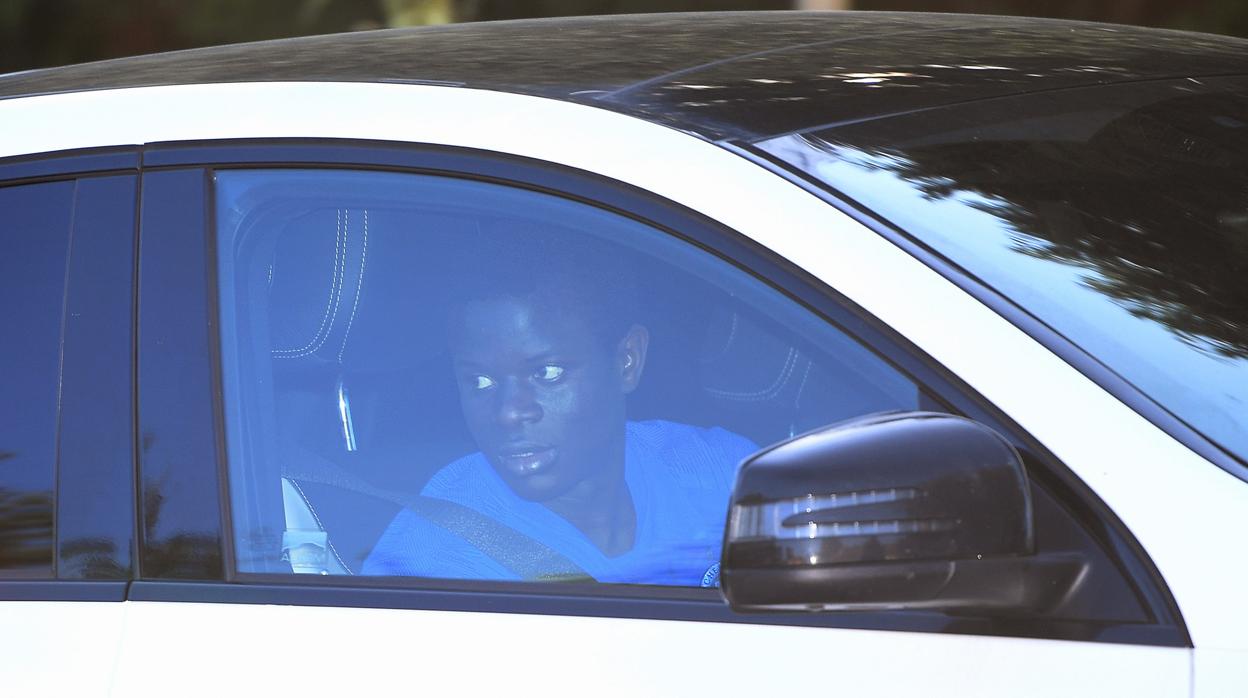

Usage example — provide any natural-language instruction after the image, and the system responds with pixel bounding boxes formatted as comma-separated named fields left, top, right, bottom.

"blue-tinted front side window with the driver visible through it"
left=216, top=170, right=932, bottom=587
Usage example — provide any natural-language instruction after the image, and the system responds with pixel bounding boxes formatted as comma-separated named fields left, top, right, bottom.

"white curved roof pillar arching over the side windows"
left=0, top=77, right=1228, bottom=644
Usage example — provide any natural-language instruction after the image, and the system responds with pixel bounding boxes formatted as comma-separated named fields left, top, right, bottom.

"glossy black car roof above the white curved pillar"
left=0, top=12, right=1248, bottom=142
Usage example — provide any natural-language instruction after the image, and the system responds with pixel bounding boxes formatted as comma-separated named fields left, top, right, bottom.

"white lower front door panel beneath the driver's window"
left=112, top=602, right=1189, bottom=697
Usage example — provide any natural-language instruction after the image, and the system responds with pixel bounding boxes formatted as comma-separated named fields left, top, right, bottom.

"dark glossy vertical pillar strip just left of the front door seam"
left=56, top=175, right=137, bottom=579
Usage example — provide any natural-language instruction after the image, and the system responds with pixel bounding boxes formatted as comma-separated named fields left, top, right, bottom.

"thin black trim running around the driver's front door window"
left=130, top=139, right=1192, bottom=647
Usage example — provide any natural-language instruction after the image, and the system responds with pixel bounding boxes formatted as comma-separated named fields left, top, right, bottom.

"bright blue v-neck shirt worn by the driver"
left=363, top=421, right=758, bottom=587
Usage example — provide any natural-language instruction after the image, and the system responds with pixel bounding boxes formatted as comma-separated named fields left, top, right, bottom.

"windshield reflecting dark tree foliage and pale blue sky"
left=761, top=79, right=1248, bottom=469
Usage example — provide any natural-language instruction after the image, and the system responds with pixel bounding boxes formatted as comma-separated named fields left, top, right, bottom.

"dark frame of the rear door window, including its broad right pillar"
left=0, top=146, right=140, bottom=602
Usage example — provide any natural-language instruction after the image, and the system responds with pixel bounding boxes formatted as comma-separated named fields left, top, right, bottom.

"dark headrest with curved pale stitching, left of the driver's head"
left=268, top=206, right=477, bottom=371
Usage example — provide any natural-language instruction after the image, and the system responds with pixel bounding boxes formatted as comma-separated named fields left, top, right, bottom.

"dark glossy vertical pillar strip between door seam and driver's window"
left=136, top=170, right=228, bottom=579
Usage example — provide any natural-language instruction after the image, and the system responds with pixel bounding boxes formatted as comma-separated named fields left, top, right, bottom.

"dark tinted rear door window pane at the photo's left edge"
left=0, top=182, right=74, bottom=577
